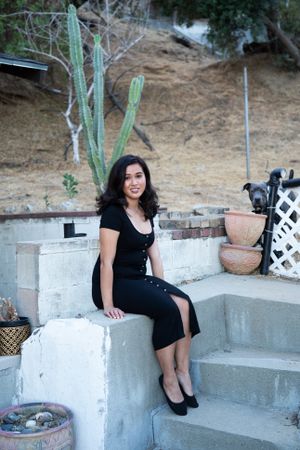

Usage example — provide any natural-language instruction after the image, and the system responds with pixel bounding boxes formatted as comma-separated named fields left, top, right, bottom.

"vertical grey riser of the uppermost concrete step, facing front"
left=225, top=296, right=300, bottom=352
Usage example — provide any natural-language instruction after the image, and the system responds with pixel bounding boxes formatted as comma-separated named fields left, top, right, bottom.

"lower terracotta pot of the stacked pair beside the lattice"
left=220, top=243, right=262, bottom=275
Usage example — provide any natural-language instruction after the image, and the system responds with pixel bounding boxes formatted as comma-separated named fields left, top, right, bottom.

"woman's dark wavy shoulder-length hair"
left=96, top=155, right=159, bottom=219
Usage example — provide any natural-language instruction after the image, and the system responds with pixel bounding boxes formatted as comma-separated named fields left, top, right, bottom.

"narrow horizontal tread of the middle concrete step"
left=197, top=347, right=300, bottom=372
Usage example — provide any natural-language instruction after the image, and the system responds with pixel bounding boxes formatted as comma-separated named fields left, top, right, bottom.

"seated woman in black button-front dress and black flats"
left=93, top=155, right=200, bottom=415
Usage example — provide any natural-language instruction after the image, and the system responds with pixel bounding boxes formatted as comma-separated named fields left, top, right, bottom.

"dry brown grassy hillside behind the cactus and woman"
left=0, top=30, right=300, bottom=213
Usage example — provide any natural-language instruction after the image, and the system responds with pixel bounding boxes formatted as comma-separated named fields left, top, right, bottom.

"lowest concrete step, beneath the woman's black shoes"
left=154, top=395, right=300, bottom=450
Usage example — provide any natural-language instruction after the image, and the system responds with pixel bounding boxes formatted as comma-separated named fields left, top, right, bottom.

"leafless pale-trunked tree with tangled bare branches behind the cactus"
left=0, top=0, right=150, bottom=163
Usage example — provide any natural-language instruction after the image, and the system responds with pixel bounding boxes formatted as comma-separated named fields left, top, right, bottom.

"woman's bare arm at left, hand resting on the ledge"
left=100, top=228, right=125, bottom=319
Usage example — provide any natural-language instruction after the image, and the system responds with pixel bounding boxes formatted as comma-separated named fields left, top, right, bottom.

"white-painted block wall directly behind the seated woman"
left=17, top=230, right=225, bottom=327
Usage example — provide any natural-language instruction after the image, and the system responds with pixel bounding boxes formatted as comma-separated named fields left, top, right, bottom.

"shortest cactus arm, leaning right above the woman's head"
left=108, top=75, right=144, bottom=177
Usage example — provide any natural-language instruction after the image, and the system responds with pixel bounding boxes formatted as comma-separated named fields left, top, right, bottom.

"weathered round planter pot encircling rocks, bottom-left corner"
left=0, top=403, right=75, bottom=450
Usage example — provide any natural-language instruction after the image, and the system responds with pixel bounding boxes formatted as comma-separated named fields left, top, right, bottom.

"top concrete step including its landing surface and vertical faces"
left=184, top=273, right=300, bottom=358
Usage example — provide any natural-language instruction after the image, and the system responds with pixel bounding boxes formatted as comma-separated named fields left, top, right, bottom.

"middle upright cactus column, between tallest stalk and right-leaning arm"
left=93, top=35, right=105, bottom=174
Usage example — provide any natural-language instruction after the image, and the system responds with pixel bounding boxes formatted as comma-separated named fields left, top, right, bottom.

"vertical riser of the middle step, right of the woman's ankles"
left=197, top=362, right=300, bottom=411
